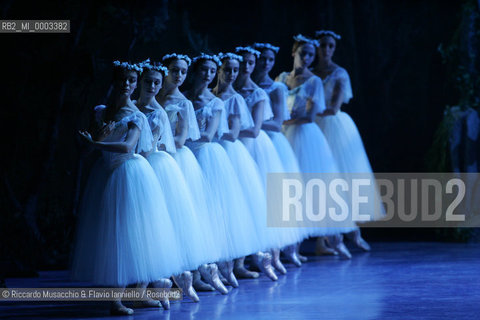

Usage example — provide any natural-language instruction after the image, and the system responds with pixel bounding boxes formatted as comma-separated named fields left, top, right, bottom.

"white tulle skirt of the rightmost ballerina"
left=316, top=111, right=385, bottom=220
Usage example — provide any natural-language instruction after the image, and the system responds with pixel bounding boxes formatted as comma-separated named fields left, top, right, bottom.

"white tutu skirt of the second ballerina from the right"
left=285, top=122, right=356, bottom=236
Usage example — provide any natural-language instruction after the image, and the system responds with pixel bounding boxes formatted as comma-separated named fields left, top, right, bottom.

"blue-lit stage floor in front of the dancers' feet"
left=0, top=242, right=480, bottom=320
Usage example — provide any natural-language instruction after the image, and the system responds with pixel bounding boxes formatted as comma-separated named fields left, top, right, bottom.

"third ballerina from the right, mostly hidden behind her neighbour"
left=252, top=43, right=316, bottom=262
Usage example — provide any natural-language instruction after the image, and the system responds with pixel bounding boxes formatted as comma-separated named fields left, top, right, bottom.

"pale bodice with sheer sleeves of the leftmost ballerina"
left=95, top=105, right=153, bottom=169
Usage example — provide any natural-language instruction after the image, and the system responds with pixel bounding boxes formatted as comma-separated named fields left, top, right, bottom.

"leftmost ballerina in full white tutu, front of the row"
left=72, top=61, right=184, bottom=315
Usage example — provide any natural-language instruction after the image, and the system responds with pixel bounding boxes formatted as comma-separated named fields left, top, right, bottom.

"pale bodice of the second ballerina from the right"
left=278, top=72, right=325, bottom=118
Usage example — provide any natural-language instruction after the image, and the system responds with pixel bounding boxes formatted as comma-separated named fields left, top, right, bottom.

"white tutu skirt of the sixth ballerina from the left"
left=242, top=130, right=305, bottom=248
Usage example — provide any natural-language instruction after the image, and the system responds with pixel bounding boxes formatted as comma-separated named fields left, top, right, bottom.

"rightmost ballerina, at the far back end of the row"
left=313, top=30, right=383, bottom=251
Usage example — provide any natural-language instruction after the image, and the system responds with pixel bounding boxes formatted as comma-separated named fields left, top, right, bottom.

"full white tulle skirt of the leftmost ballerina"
left=72, top=155, right=184, bottom=287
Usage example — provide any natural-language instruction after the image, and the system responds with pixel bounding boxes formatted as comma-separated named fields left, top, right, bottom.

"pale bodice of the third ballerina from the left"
left=164, top=97, right=200, bottom=141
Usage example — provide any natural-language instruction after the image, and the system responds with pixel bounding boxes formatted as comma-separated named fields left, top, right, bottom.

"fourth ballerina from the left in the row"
left=185, top=54, right=274, bottom=282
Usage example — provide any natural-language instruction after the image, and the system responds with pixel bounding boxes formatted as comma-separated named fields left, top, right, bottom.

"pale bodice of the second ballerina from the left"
left=145, top=107, right=176, bottom=153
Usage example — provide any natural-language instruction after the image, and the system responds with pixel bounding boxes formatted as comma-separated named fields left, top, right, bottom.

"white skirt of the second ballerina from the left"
left=147, top=151, right=219, bottom=270
